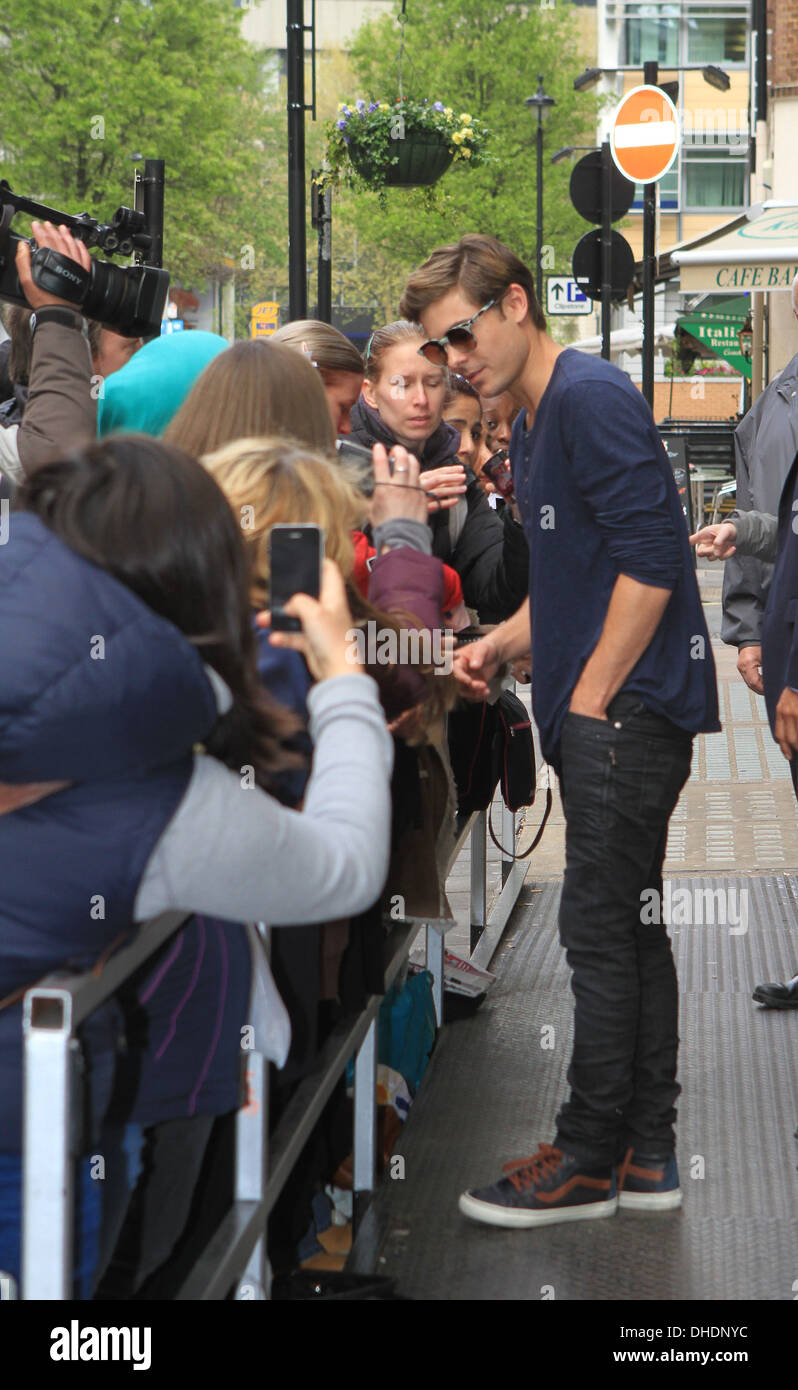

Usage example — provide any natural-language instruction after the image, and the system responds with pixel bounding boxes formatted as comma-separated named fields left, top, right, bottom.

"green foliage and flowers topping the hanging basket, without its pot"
left=324, top=97, right=488, bottom=189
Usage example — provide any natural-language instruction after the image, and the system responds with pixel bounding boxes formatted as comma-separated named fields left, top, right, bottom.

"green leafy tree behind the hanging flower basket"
left=319, top=0, right=596, bottom=322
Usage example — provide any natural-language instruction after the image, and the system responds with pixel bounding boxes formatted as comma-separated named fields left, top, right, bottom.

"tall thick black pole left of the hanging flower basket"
left=285, top=0, right=307, bottom=318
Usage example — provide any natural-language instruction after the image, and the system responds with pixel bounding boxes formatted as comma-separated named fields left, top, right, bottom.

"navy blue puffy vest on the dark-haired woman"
left=0, top=512, right=217, bottom=1152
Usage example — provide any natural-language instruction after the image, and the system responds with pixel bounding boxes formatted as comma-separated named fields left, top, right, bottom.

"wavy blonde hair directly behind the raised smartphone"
left=202, top=438, right=367, bottom=605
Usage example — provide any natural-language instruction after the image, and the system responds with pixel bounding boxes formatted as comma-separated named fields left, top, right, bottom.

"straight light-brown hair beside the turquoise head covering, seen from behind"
left=164, top=339, right=335, bottom=459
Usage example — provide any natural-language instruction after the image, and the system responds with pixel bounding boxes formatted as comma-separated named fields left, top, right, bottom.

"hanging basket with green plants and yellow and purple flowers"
left=323, top=99, right=488, bottom=192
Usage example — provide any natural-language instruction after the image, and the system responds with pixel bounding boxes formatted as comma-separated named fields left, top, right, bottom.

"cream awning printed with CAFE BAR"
left=670, top=202, right=798, bottom=293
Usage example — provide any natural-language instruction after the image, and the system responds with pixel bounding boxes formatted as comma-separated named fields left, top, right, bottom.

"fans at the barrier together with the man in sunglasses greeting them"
left=0, top=214, right=798, bottom=1298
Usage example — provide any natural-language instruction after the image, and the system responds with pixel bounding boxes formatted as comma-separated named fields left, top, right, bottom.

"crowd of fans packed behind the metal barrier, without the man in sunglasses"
left=0, top=224, right=539, bottom=1297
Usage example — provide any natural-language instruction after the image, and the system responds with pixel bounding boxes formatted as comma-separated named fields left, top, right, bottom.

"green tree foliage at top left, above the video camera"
left=0, top=0, right=285, bottom=284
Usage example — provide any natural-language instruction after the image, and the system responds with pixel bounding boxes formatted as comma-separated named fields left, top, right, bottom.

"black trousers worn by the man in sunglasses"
left=555, top=694, right=692, bottom=1166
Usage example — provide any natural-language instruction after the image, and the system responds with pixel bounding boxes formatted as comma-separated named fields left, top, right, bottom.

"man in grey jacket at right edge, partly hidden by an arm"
left=720, top=275, right=798, bottom=695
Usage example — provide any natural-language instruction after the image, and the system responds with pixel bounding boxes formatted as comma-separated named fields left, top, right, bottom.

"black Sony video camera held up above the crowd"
left=0, top=179, right=170, bottom=338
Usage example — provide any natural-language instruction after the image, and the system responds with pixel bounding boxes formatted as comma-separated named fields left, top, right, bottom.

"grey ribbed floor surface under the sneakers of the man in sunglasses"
left=350, top=874, right=798, bottom=1301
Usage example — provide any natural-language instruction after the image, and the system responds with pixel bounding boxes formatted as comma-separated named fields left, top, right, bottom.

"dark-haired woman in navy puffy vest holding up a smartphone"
left=0, top=436, right=393, bottom=1297
